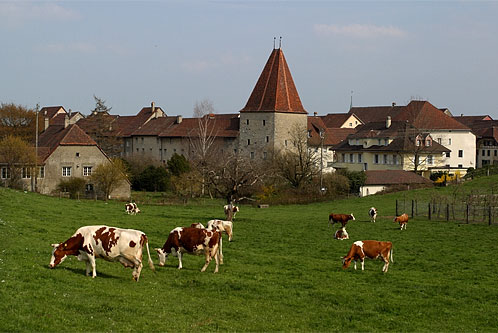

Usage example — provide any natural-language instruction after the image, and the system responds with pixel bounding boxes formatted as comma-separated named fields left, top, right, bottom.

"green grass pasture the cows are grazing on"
left=0, top=177, right=498, bottom=332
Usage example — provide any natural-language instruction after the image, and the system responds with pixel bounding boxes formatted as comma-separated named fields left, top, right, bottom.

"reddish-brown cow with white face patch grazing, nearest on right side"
left=342, top=240, right=394, bottom=273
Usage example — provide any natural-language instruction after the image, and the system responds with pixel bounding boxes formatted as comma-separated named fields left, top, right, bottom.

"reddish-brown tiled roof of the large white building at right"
left=349, top=101, right=469, bottom=130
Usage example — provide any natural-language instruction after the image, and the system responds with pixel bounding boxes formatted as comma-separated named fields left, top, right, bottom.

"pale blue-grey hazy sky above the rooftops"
left=0, top=0, right=498, bottom=119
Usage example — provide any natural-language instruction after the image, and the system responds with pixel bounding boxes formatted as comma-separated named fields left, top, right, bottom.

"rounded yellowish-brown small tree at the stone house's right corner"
left=91, top=158, right=128, bottom=200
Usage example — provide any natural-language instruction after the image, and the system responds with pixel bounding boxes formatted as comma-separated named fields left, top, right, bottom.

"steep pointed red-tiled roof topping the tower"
left=240, top=49, right=307, bottom=113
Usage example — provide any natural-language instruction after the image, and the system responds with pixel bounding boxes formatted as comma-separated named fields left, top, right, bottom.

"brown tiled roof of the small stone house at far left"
left=38, top=124, right=97, bottom=160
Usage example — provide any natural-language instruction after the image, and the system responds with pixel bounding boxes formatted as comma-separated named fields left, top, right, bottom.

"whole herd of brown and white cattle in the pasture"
left=49, top=202, right=408, bottom=281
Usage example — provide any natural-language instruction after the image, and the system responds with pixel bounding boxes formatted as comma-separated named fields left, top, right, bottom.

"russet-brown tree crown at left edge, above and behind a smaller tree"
left=0, top=103, right=42, bottom=142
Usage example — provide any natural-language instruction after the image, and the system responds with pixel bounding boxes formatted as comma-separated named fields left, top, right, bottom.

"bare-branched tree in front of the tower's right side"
left=274, top=125, right=320, bottom=188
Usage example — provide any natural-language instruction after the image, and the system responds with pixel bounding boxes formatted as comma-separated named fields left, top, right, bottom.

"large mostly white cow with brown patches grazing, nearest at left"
left=49, top=225, right=154, bottom=282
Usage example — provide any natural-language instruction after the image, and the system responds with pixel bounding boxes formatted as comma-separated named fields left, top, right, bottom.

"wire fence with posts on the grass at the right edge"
left=396, top=199, right=498, bottom=225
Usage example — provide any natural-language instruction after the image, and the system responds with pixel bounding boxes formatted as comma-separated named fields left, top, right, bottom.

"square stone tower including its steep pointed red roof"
left=239, top=48, right=308, bottom=159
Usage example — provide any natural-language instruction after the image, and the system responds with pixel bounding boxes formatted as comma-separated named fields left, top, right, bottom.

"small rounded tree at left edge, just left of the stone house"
left=0, top=135, right=36, bottom=188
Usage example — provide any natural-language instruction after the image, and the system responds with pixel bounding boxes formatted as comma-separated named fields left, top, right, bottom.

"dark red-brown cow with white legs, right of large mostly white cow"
left=156, top=227, right=221, bottom=273
